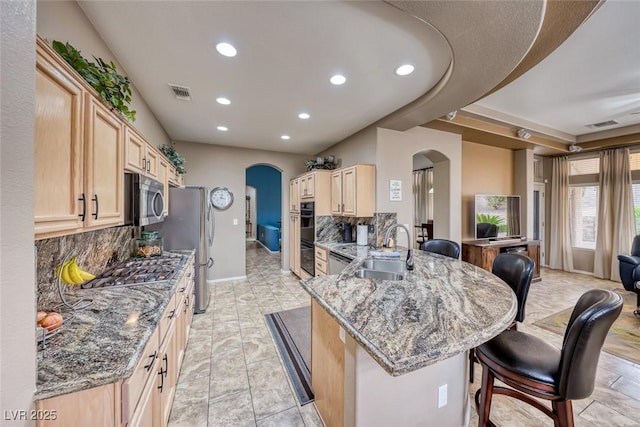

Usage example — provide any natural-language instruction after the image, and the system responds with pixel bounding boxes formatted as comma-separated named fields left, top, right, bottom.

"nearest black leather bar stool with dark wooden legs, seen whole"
left=475, top=289, right=622, bottom=427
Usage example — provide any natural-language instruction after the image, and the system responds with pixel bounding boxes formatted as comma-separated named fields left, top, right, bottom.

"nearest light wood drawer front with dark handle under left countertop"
left=122, top=328, right=160, bottom=424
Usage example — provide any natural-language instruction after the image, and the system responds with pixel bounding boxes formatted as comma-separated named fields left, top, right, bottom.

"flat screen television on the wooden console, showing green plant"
left=474, top=194, right=520, bottom=240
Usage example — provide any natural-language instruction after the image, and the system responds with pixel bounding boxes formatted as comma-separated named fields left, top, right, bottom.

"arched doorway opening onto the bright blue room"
left=245, top=164, right=282, bottom=262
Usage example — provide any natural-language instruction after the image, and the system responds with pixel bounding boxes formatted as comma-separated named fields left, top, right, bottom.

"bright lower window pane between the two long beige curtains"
left=569, top=185, right=598, bottom=249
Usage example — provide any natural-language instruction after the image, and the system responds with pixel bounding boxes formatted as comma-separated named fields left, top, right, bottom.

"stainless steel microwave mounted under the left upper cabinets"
left=124, top=173, right=165, bottom=225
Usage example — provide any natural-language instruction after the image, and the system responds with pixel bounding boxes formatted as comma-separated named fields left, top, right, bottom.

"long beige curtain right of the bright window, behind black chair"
left=593, top=148, right=635, bottom=282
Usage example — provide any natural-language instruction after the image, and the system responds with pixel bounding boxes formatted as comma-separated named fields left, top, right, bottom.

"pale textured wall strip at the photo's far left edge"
left=0, top=1, right=36, bottom=426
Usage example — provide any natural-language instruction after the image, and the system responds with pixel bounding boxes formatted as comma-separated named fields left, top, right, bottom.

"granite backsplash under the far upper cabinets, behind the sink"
left=315, top=212, right=397, bottom=247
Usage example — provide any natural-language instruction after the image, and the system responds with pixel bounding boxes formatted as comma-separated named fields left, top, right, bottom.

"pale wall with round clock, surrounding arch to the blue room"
left=176, top=142, right=309, bottom=280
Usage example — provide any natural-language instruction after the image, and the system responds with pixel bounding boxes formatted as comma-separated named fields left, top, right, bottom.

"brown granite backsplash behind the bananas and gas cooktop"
left=35, top=226, right=139, bottom=310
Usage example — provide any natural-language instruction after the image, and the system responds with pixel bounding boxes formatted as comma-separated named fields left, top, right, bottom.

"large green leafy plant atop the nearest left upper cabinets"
left=51, top=40, right=136, bottom=122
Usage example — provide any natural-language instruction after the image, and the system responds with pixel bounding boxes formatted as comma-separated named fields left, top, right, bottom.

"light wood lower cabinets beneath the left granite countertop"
left=36, top=263, right=195, bottom=427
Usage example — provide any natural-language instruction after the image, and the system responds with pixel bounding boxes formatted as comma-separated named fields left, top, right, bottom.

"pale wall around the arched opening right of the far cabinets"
left=375, top=126, right=462, bottom=245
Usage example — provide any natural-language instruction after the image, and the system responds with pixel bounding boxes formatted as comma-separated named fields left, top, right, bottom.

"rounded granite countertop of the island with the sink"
left=301, top=243, right=517, bottom=376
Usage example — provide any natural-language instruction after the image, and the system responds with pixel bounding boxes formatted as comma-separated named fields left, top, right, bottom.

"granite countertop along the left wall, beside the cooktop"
left=34, top=251, right=195, bottom=400
